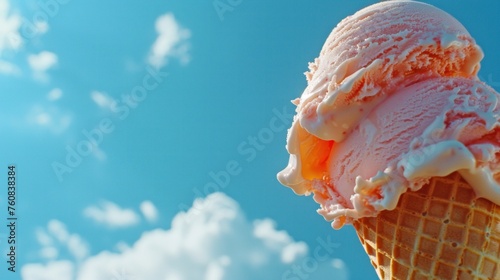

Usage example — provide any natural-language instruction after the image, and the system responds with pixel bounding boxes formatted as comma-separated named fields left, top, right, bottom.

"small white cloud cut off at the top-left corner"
left=0, top=0, right=22, bottom=53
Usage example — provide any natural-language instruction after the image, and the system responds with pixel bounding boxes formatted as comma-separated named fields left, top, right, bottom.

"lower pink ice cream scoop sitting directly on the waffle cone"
left=318, top=77, right=500, bottom=228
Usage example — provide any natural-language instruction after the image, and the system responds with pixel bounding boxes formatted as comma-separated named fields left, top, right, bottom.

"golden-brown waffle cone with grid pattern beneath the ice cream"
left=354, top=173, right=500, bottom=279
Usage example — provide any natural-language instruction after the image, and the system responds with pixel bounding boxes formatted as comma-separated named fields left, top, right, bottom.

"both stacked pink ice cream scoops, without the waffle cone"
left=278, top=1, right=500, bottom=228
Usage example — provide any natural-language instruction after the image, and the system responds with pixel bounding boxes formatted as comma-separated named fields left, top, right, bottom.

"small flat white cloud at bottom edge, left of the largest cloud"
left=21, top=261, right=74, bottom=280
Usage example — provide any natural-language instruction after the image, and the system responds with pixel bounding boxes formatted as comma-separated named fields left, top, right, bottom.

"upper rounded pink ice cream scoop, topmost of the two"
left=297, top=1, right=483, bottom=142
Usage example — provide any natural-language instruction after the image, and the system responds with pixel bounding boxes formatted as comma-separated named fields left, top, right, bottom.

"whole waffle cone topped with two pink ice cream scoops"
left=278, top=0, right=500, bottom=279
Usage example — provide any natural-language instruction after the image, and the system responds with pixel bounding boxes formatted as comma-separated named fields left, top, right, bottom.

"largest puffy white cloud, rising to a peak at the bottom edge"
left=78, top=193, right=305, bottom=280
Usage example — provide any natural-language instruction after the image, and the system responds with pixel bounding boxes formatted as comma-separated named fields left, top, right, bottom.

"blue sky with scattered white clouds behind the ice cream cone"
left=0, top=0, right=500, bottom=280
